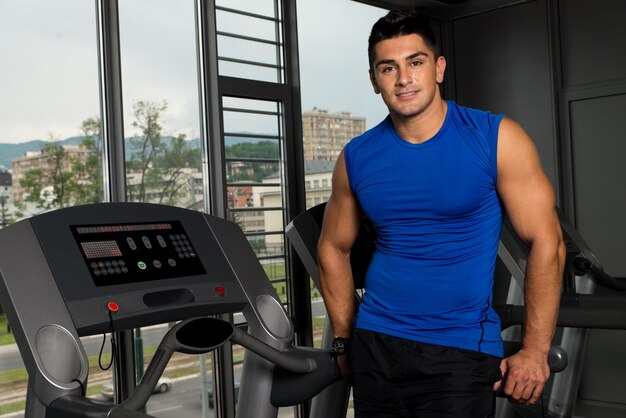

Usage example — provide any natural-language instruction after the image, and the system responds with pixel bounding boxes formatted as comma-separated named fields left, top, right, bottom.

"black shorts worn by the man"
left=348, top=329, right=502, bottom=418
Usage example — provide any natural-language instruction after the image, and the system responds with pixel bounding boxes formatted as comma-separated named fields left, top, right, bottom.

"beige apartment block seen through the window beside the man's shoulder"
left=302, top=107, right=365, bottom=161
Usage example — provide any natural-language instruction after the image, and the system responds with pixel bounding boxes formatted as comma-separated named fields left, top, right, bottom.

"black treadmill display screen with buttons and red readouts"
left=70, top=221, right=206, bottom=286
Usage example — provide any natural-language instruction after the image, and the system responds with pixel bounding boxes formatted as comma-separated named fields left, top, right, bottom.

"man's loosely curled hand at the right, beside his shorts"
left=493, top=349, right=550, bottom=405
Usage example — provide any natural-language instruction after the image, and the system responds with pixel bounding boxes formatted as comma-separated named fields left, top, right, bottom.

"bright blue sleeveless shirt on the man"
left=344, top=101, right=503, bottom=356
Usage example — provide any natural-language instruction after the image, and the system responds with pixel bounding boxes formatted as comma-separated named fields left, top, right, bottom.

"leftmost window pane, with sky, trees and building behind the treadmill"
left=0, top=0, right=101, bottom=415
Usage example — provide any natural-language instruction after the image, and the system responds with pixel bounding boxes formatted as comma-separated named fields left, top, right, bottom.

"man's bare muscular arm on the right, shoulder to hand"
left=494, top=118, right=565, bottom=405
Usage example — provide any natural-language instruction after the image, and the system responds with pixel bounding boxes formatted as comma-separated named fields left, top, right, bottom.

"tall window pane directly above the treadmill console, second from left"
left=119, top=0, right=204, bottom=210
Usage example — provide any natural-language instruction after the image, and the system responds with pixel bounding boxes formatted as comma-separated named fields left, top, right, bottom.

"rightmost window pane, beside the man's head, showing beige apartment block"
left=298, top=0, right=387, bottom=416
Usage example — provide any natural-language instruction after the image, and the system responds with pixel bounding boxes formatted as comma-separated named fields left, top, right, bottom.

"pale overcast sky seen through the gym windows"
left=0, top=0, right=386, bottom=143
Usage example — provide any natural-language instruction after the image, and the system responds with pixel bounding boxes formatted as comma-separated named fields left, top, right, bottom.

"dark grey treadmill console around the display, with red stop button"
left=18, top=203, right=254, bottom=336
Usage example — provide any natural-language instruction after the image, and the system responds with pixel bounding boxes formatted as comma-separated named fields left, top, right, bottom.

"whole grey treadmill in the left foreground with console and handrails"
left=0, top=203, right=340, bottom=418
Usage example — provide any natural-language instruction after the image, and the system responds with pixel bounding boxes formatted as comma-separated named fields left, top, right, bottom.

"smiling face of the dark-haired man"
left=370, top=34, right=446, bottom=118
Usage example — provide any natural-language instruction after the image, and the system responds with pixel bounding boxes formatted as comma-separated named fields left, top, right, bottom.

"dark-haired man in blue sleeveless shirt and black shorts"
left=318, top=10, right=565, bottom=418
